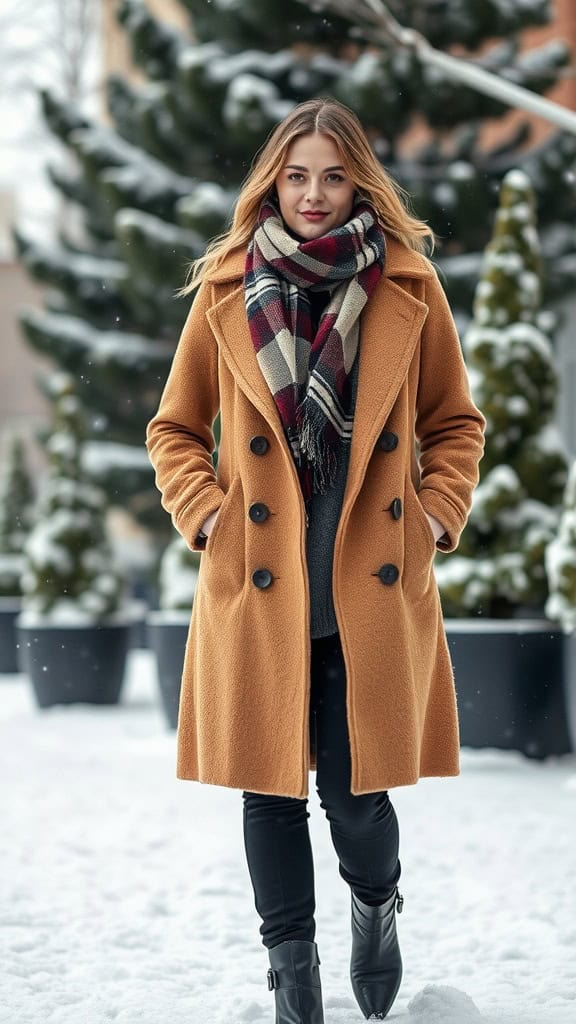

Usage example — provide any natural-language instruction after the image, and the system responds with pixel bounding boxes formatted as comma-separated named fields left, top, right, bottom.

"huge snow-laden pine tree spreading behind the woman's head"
left=16, top=0, right=576, bottom=565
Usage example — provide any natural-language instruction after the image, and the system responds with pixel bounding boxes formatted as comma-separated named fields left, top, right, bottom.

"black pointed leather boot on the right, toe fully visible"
left=351, top=886, right=404, bottom=1021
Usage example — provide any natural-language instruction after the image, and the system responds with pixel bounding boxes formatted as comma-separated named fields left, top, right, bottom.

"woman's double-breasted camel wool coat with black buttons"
left=147, top=234, right=486, bottom=799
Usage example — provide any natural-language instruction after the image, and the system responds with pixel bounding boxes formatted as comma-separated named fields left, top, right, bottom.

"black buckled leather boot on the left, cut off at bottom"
left=268, top=939, right=324, bottom=1024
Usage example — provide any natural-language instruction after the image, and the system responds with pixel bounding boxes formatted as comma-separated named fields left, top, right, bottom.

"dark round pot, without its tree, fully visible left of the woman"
left=16, top=621, right=132, bottom=708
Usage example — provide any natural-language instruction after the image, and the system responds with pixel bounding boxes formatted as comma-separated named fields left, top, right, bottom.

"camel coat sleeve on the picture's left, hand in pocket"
left=146, top=282, right=224, bottom=551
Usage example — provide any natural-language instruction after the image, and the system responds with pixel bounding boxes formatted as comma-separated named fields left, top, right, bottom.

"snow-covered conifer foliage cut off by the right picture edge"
left=545, top=462, right=576, bottom=633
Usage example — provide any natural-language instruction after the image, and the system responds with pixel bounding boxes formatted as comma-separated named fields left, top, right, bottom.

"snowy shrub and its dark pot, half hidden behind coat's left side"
left=148, top=535, right=202, bottom=729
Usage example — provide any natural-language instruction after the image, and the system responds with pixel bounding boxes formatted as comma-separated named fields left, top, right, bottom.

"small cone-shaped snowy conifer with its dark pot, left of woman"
left=16, top=373, right=131, bottom=708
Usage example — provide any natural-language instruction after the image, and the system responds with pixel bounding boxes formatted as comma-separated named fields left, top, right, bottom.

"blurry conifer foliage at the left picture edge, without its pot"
left=0, top=433, right=34, bottom=597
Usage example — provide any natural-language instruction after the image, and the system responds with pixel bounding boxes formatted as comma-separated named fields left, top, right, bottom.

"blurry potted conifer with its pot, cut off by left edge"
left=0, top=434, right=34, bottom=673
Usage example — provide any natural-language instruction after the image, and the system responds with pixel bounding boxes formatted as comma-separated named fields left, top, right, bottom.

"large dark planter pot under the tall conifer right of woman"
left=445, top=618, right=576, bottom=759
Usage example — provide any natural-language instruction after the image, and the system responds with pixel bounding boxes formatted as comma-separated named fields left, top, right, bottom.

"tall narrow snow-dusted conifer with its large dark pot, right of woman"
left=435, top=170, right=572, bottom=758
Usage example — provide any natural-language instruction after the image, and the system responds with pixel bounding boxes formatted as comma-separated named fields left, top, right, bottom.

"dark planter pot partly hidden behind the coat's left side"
left=148, top=611, right=191, bottom=729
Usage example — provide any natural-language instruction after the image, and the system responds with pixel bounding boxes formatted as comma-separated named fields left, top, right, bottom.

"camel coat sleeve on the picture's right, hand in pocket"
left=415, top=271, right=486, bottom=552
